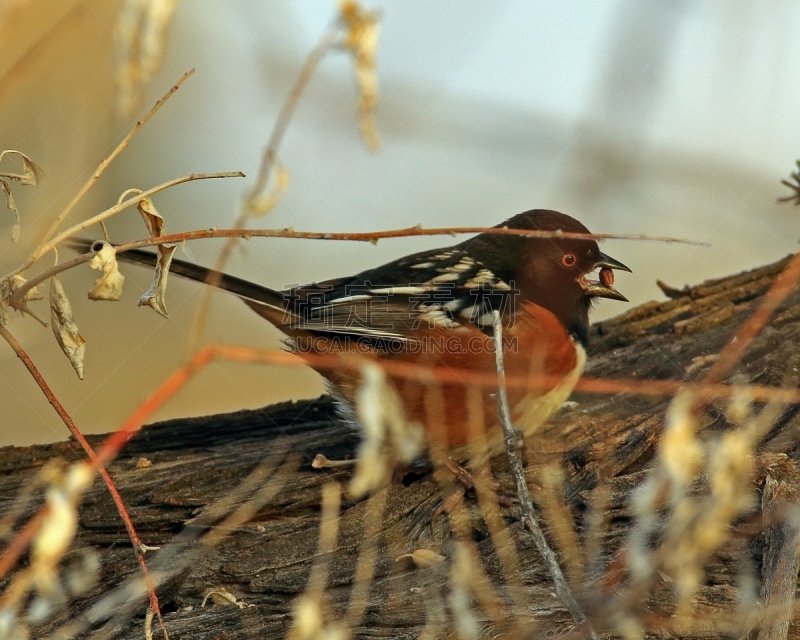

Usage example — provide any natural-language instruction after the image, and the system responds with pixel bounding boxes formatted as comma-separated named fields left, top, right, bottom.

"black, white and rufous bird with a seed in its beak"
left=73, top=209, right=631, bottom=455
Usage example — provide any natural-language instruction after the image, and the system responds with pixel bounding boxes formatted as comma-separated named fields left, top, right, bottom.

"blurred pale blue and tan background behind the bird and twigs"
left=0, top=0, right=800, bottom=444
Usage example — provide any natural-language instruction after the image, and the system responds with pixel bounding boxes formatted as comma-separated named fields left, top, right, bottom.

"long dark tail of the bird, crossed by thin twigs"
left=69, top=239, right=286, bottom=311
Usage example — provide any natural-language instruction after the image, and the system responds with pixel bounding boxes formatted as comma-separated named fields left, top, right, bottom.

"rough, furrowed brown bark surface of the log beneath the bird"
left=0, top=252, right=800, bottom=640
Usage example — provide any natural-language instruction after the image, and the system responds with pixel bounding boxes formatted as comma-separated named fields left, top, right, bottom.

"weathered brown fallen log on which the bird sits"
left=0, top=252, right=800, bottom=640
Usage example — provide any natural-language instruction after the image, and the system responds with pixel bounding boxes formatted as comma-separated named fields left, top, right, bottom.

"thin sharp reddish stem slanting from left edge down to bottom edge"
left=0, top=324, right=169, bottom=639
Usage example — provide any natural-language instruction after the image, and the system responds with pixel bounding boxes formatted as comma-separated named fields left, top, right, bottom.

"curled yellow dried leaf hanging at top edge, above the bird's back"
left=339, top=0, right=381, bottom=151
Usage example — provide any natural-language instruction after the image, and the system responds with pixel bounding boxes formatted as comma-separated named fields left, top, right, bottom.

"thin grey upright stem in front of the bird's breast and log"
left=492, top=310, right=598, bottom=640
